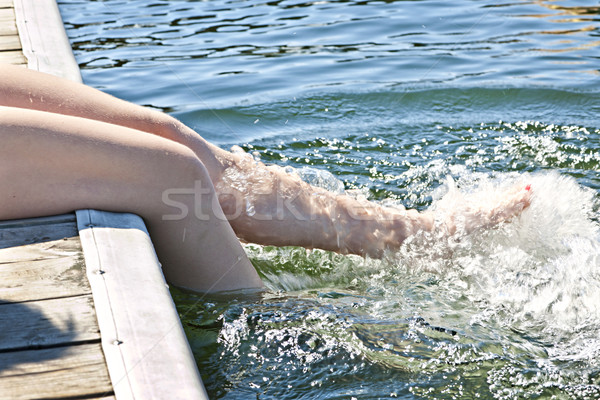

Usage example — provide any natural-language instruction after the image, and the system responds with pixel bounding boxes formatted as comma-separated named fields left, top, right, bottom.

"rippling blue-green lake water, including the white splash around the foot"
left=59, top=0, right=600, bottom=399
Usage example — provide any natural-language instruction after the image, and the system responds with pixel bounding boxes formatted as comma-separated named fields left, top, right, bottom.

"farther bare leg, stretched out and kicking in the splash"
left=0, top=66, right=529, bottom=256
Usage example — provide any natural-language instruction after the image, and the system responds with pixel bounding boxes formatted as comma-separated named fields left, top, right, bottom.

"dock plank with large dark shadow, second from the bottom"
left=0, top=294, right=100, bottom=351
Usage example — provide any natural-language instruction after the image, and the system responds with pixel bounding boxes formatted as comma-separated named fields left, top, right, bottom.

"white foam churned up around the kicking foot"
left=422, top=172, right=600, bottom=337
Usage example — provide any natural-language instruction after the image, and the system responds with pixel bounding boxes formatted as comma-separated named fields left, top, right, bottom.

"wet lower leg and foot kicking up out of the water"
left=216, top=156, right=531, bottom=257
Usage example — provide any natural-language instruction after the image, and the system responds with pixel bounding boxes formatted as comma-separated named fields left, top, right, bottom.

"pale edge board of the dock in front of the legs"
left=77, top=210, right=207, bottom=400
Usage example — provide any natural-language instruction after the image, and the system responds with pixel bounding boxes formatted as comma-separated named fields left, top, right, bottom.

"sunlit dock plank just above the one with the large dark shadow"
left=0, top=237, right=91, bottom=304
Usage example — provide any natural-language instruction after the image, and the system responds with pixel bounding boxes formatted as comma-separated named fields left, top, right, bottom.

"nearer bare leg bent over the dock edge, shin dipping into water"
left=0, top=107, right=262, bottom=291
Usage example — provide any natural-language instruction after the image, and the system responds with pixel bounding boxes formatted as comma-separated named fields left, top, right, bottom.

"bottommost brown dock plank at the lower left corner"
left=0, top=344, right=113, bottom=400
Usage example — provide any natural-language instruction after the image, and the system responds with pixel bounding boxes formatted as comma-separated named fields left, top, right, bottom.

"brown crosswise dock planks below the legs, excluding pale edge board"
left=0, top=214, right=114, bottom=399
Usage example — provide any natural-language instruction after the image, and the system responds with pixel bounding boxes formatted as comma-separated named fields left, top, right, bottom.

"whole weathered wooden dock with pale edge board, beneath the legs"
left=0, top=0, right=207, bottom=400
